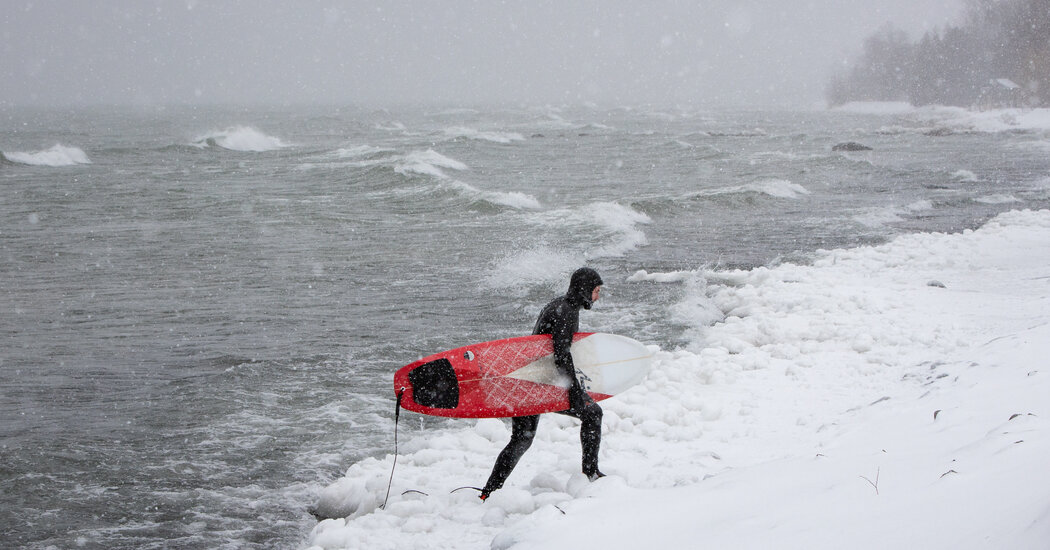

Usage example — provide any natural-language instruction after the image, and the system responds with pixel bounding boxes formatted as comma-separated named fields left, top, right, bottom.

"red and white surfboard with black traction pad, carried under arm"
left=394, top=333, right=653, bottom=418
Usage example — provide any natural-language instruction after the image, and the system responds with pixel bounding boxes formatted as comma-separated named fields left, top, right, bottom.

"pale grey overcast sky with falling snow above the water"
left=0, top=0, right=962, bottom=105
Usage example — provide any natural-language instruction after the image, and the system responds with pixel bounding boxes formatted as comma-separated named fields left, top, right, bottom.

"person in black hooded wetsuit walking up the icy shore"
left=481, top=268, right=605, bottom=501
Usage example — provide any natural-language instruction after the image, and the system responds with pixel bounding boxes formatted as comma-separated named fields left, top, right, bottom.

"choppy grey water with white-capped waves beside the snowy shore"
left=0, top=106, right=1050, bottom=548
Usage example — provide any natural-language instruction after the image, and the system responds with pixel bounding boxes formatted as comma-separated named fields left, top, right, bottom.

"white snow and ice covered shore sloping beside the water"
left=309, top=211, right=1050, bottom=550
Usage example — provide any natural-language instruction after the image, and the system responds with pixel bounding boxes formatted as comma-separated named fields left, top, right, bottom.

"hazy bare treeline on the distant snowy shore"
left=826, top=0, right=1050, bottom=107
